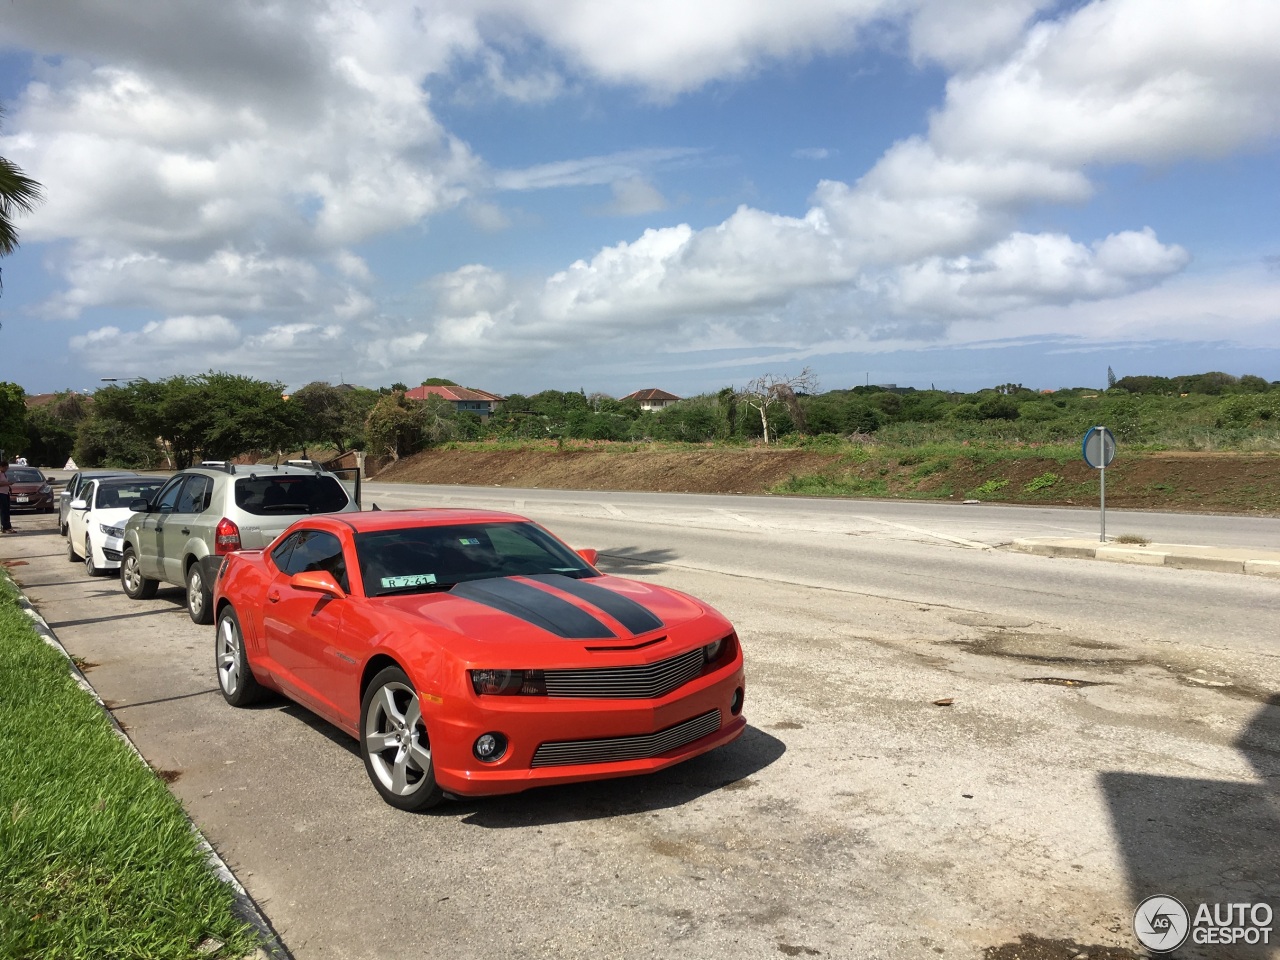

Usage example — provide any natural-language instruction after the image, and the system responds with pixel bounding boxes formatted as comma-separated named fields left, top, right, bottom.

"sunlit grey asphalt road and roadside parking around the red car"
left=0, top=496, right=1280, bottom=960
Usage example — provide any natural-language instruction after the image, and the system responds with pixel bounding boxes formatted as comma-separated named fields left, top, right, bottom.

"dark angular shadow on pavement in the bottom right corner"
left=1101, top=694, right=1280, bottom=960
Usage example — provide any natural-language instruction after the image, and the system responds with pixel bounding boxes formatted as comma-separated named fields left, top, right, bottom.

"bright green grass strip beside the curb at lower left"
left=0, top=575, right=257, bottom=960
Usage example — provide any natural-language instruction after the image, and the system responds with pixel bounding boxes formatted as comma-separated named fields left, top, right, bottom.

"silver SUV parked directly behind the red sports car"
left=120, top=462, right=360, bottom=623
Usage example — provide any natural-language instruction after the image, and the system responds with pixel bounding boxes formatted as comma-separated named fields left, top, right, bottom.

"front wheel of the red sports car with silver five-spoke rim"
left=360, top=667, right=444, bottom=812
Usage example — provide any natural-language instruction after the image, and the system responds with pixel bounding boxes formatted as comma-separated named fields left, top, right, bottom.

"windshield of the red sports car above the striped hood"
left=356, top=522, right=596, bottom=596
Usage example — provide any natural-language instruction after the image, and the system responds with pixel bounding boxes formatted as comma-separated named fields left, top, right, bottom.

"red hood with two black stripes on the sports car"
left=378, top=575, right=708, bottom=648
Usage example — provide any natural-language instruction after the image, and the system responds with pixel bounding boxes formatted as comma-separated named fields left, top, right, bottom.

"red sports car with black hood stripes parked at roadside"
left=214, top=509, right=746, bottom=810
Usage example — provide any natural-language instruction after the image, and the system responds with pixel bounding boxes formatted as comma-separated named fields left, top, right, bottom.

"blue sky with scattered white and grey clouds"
left=0, top=0, right=1280, bottom=396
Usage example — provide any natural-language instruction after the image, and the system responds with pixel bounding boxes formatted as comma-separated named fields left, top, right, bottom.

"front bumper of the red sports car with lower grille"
left=424, top=659, right=746, bottom=796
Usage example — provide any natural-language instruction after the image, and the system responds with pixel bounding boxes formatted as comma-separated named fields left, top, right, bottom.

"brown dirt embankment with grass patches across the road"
left=376, top=448, right=1280, bottom=516
